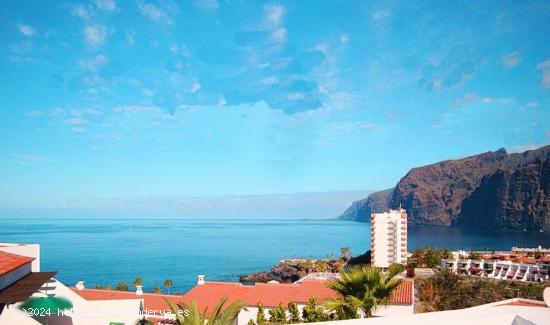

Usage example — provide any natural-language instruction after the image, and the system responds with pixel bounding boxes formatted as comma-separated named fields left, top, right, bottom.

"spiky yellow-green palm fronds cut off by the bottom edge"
left=164, top=297, right=246, bottom=325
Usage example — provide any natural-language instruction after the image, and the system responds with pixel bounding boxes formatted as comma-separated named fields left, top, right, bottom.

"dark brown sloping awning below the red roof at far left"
left=0, top=272, right=57, bottom=304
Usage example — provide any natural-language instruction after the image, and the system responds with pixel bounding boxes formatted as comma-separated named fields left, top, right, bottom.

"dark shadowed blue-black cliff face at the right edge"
left=455, top=158, right=550, bottom=230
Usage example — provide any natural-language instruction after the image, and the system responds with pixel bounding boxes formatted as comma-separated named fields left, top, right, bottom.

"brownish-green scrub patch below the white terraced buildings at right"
left=415, top=271, right=548, bottom=312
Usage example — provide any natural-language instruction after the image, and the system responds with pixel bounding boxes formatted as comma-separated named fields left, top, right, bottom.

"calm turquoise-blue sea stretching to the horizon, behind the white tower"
left=0, top=219, right=550, bottom=292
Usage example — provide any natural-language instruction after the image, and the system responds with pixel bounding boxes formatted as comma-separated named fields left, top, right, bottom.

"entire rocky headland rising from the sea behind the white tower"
left=339, top=145, right=550, bottom=230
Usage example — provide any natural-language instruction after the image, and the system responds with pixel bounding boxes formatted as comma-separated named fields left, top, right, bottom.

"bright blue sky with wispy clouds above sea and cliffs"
left=0, top=0, right=550, bottom=217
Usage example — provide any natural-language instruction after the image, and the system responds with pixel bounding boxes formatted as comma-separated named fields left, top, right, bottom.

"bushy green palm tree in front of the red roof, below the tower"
left=326, top=266, right=401, bottom=319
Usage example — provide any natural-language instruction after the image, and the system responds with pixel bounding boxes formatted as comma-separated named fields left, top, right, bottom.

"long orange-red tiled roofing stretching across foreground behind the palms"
left=73, top=280, right=413, bottom=316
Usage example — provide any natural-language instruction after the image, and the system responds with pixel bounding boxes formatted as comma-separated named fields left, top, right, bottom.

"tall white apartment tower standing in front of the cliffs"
left=370, top=208, right=407, bottom=268
